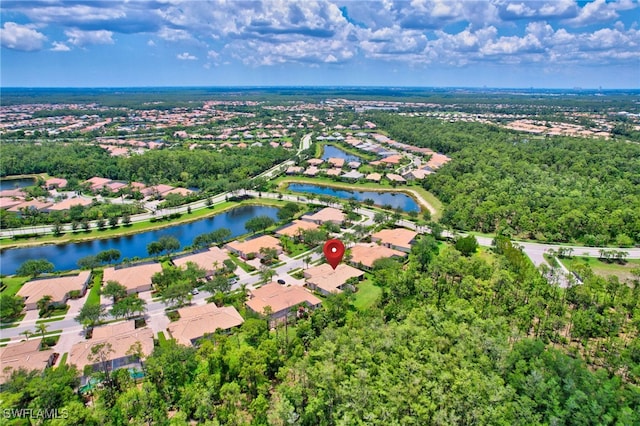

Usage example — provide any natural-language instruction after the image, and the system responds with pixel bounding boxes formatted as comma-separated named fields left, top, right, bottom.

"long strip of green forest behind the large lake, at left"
left=0, top=142, right=291, bottom=191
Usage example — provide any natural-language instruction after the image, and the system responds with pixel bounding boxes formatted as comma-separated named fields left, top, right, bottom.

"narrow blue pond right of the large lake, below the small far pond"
left=289, top=183, right=420, bottom=212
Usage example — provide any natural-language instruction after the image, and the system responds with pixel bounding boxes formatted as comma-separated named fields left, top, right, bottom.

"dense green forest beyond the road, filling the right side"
left=374, top=114, right=640, bottom=246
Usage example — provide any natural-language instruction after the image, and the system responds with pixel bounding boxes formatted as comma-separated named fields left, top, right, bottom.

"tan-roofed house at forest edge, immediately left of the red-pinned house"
left=246, top=282, right=322, bottom=322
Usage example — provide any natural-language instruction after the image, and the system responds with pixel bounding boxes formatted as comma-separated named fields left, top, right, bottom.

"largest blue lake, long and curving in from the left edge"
left=0, top=206, right=279, bottom=275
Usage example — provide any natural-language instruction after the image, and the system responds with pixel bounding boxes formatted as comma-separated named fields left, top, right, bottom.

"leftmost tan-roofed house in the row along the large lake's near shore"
left=16, top=271, right=91, bottom=311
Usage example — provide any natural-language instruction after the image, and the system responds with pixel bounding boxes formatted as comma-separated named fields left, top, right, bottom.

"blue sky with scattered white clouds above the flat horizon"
left=0, top=0, right=640, bottom=89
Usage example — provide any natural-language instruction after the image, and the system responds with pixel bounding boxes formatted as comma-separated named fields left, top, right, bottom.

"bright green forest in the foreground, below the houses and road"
left=0, top=236, right=640, bottom=426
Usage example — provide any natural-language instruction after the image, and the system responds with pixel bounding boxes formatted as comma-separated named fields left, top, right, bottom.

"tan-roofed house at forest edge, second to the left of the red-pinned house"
left=167, top=303, right=244, bottom=346
